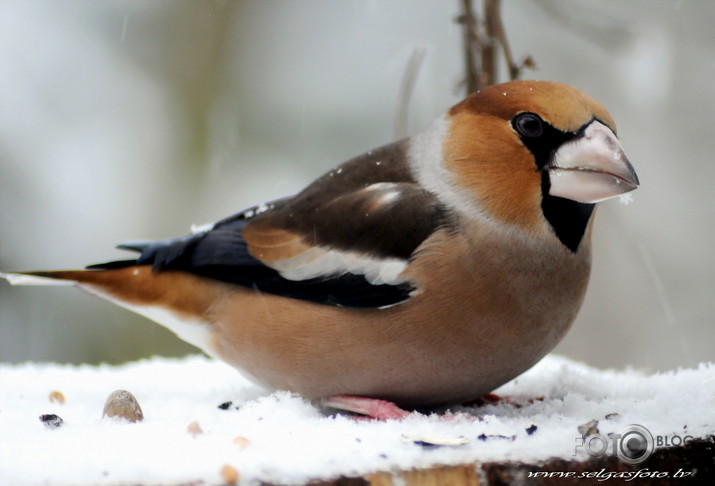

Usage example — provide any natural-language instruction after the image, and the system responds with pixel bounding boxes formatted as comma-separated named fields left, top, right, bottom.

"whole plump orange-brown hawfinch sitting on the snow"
left=4, top=81, right=638, bottom=418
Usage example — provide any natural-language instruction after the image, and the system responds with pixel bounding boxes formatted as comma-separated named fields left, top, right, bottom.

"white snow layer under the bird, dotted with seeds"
left=0, top=356, right=715, bottom=486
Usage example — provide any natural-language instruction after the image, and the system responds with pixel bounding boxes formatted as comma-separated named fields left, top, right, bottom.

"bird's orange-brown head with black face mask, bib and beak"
left=442, top=81, right=639, bottom=251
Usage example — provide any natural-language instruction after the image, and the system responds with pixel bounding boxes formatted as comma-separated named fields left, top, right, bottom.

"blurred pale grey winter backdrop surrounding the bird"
left=0, top=0, right=715, bottom=371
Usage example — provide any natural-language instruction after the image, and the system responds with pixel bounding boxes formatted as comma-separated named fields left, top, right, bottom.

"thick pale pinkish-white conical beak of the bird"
left=546, top=120, right=639, bottom=203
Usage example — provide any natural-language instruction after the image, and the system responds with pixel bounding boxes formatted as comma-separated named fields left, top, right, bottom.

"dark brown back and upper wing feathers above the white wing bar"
left=243, top=141, right=445, bottom=274
